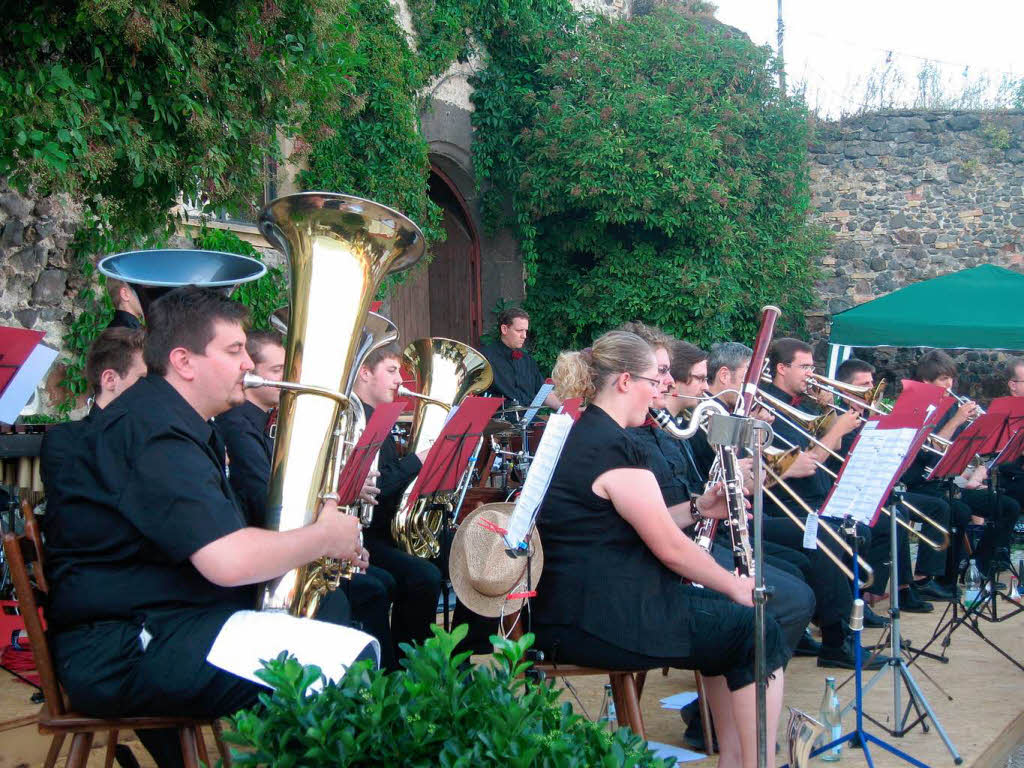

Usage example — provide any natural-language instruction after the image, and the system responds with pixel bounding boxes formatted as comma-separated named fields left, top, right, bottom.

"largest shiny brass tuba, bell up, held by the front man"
left=256, top=193, right=424, bottom=616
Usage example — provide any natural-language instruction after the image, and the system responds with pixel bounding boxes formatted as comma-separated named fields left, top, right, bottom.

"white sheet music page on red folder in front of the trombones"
left=821, top=421, right=918, bottom=525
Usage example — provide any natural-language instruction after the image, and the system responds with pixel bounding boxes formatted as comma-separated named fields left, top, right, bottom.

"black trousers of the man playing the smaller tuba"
left=365, top=536, right=441, bottom=659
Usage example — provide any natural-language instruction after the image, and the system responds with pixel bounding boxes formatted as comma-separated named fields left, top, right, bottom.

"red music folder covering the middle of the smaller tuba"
left=409, top=397, right=502, bottom=504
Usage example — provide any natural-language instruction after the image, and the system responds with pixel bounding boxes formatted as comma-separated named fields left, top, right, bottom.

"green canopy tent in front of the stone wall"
left=828, top=264, right=1024, bottom=372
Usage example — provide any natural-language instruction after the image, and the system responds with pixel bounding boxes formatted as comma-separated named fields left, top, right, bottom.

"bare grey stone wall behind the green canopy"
left=808, top=112, right=1024, bottom=399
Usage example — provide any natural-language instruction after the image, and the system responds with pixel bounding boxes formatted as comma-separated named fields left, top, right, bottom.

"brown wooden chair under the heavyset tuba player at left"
left=3, top=503, right=231, bottom=768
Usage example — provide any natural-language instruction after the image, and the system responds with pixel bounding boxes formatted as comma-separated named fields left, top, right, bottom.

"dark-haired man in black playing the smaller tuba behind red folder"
left=352, top=344, right=441, bottom=659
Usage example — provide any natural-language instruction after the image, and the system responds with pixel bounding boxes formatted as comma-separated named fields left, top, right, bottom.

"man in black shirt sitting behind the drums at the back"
left=480, top=307, right=562, bottom=409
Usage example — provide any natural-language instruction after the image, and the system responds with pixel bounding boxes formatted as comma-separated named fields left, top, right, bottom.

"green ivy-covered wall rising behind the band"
left=0, top=0, right=822, bottom=415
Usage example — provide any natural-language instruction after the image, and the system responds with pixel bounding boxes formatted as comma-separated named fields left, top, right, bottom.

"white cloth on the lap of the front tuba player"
left=206, top=610, right=381, bottom=691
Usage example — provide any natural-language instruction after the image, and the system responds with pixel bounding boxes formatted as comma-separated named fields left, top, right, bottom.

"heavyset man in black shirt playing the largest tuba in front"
left=47, top=286, right=369, bottom=766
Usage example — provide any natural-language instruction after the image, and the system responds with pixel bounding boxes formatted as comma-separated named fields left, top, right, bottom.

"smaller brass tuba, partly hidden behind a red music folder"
left=391, top=338, right=495, bottom=558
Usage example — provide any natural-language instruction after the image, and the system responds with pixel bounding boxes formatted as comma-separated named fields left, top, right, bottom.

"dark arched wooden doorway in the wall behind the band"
left=391, top=166, right=483, bottom=346
